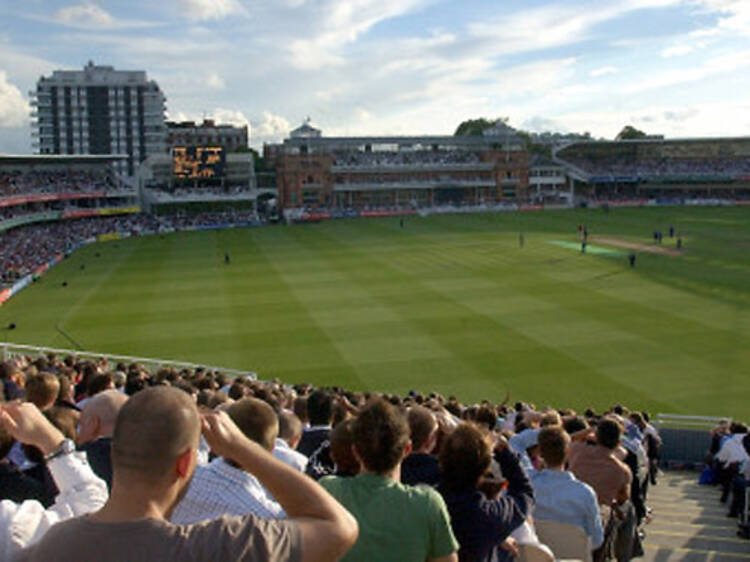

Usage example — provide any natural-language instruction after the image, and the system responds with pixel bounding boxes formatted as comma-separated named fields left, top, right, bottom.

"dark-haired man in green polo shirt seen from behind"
left=320, top=399, right=458, bottom=562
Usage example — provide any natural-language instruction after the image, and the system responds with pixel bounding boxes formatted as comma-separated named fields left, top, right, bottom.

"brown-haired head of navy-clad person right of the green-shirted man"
left=439, top=422, right=492, bottom=491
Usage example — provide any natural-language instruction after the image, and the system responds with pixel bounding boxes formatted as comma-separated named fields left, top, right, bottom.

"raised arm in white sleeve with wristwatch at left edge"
left=0, top=402, right=107, bottom=560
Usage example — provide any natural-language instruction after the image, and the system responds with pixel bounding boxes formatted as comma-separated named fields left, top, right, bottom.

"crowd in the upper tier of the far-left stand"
left=0, top=170, right=119, bottom=197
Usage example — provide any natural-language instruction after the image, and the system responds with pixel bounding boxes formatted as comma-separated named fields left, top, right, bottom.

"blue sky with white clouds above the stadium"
left=0, top=0, right=750, bottom=154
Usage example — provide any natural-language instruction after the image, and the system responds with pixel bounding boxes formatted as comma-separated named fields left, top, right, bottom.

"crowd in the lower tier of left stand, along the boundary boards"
left=0, top=211, right=257, bottom=285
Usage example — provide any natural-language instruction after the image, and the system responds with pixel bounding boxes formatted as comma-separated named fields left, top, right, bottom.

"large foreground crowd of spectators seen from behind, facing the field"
left=0, top=348, right=692, bottom=562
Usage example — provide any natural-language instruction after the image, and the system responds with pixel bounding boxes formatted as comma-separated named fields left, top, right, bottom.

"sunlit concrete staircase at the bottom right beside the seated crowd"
left=640, top=471, right=750, bottom=562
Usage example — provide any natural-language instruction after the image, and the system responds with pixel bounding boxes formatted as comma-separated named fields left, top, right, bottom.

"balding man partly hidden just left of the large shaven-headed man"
left=76, top=390, right=128, bottom=489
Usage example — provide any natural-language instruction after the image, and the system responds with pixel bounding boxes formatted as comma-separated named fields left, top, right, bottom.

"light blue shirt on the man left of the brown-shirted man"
left=531, top=470, right=604, bottom=548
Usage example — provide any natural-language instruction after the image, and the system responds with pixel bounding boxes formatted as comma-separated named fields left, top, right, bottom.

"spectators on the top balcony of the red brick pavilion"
left=333, top=150, right=480, bottom=168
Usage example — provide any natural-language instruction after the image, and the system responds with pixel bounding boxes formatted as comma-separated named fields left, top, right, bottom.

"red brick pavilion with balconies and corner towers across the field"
left=264, top=119, right=529, bottom=209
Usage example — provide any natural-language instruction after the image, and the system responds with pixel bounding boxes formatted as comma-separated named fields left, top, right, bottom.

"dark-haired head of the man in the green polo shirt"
left=352, top=398, right=411, bottom=475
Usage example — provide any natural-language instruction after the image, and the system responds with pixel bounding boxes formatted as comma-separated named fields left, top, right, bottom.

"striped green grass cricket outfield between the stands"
left=0, top=208, right=750, bottom=419
